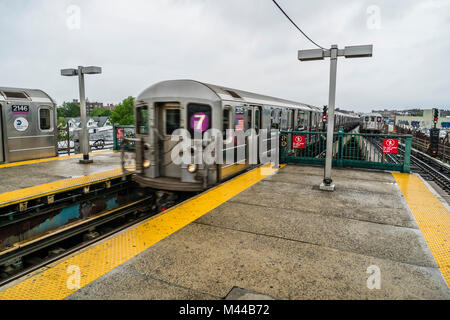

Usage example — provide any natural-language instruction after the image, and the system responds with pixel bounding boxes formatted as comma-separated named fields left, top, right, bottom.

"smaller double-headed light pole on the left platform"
left=61, top=66, right=102, bottom=164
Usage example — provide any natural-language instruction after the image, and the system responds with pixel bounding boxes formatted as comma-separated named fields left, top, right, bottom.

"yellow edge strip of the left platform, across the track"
left=0, top=168, right=126, bottom=208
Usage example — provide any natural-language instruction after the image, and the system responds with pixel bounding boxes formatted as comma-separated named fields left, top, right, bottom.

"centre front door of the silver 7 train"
left=157, top=103, right=181, bottom=178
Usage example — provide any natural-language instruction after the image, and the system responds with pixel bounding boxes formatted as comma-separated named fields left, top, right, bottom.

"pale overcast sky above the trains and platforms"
left=0, top=0, right=450, bottom=111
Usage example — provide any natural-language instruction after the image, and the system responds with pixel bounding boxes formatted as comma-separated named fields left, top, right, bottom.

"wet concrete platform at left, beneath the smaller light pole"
left=0, top=151, right=121, bottom=194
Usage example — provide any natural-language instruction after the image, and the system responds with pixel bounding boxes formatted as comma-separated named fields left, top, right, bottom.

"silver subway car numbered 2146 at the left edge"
left=0, top=87, right=58, bottom=163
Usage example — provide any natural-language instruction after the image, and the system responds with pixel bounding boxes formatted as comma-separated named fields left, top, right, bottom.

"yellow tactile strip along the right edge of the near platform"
left=392, top=173, right=450, bottom=286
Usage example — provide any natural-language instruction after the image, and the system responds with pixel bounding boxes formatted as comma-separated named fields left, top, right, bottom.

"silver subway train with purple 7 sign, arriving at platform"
left=123, top=80, right=319, bottom=192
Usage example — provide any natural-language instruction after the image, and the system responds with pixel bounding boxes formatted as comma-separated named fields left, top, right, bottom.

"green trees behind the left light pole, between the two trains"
left=57, top=97, right=134, bottom=126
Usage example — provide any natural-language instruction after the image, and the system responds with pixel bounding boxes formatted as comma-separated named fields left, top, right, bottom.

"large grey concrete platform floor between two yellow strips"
left=62, top=166, right=450, bottom=299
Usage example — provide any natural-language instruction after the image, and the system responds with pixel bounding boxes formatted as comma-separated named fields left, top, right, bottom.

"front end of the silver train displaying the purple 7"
left=126, top=80, right=222, bottom=191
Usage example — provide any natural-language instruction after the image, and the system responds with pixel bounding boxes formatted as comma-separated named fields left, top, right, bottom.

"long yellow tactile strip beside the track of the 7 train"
left=0, top=165, right=284, bottom=300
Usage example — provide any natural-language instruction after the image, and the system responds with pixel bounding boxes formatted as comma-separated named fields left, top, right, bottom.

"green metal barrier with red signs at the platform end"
left=280, top=131, right=412, bottom=172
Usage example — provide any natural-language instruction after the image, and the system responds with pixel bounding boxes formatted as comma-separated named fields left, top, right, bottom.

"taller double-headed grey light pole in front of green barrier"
left=298, top=45, right=373, bottom=191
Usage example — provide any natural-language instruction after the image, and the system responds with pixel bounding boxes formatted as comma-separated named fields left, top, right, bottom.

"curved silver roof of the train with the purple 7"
left=137, top=79, right=320, bottom=112
